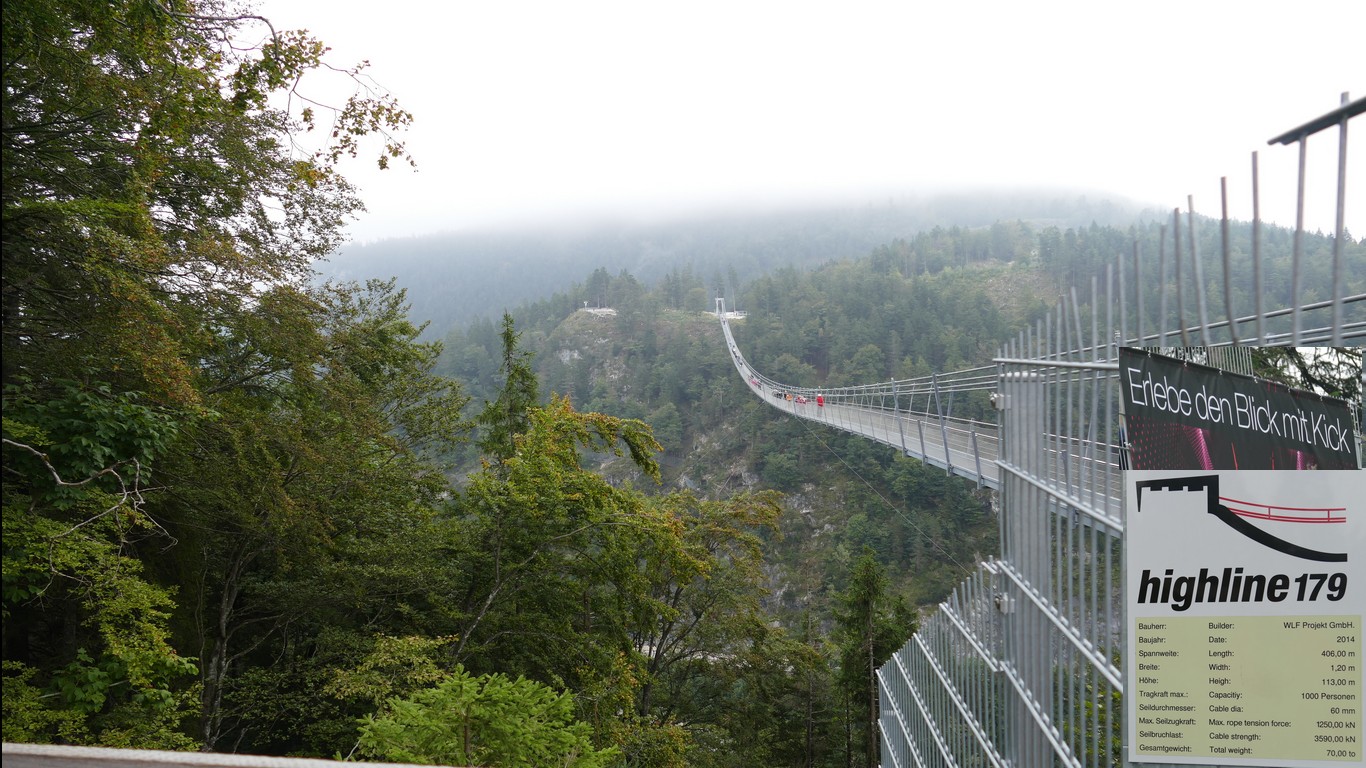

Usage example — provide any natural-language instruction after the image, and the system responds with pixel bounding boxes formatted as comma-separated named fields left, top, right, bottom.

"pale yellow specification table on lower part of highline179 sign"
left=1131, top=615, right=1363, bottom=763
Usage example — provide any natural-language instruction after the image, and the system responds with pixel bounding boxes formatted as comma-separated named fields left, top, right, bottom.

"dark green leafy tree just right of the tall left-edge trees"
left=164, top=277, right=466, bottom=753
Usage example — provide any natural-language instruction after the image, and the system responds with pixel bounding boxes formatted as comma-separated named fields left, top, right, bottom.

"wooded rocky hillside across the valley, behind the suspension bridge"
left=441, top=213, right=1366, bottom=615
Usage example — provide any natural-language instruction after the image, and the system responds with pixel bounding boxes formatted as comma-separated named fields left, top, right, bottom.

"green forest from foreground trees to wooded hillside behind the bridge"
left=0, top=0, right=1366, bottom=767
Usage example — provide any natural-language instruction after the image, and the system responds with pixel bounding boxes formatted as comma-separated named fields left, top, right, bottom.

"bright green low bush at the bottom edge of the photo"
left=361, top=666, right=617, bottom=768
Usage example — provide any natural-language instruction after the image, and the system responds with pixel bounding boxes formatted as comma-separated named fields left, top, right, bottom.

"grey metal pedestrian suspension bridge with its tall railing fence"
left=716, top=94, right=1366, bottom=768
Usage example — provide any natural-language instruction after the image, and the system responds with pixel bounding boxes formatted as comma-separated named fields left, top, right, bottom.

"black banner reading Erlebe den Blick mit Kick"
left=1119, top=347, right=1358, bottom=470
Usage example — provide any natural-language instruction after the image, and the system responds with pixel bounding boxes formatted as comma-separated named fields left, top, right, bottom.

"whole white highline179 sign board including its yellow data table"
left=1124, top=470, right=1366, bottom=767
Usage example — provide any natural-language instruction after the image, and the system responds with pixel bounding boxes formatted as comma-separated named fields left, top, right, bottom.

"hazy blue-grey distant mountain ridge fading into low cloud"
left=317, top=190, right=1138, bottom=338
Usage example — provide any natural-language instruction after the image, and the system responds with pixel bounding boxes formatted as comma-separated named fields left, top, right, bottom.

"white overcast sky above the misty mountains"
left=260, top=0, right=1366, bottom=242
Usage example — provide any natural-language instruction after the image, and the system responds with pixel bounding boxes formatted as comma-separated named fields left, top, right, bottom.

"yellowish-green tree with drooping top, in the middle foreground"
left=458, top=399, right=661, bottom=682
